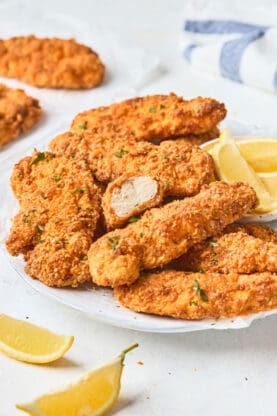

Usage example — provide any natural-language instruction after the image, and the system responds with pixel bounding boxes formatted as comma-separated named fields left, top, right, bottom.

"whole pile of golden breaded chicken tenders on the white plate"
left=6, top=93, right=277, bottom=319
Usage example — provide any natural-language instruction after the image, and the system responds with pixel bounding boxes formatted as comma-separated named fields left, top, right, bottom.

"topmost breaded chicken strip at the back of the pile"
left=71, top=93, right=226, bottom=140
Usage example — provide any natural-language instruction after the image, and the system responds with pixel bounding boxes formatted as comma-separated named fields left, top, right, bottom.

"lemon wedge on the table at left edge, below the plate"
left=0, top=314, right=74, bottom=364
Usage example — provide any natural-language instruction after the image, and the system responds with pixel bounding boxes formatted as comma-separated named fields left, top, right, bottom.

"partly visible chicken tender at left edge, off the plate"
left=0, top=82, right=41, bottom=148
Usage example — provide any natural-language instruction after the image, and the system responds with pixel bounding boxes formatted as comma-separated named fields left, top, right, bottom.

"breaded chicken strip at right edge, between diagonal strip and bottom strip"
left=174, top=225, right=277, bottom=274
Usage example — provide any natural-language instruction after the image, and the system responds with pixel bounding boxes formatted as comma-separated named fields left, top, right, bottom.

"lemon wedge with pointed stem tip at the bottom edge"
left=16, top=344, right=138, bottom=416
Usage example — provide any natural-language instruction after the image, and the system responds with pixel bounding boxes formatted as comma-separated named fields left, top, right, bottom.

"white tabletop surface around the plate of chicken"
left=0, top=0, right=277, bottom=416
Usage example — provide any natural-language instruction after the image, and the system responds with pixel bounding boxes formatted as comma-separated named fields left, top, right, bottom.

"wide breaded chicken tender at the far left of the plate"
left=6, top=152, right=100, bottom=287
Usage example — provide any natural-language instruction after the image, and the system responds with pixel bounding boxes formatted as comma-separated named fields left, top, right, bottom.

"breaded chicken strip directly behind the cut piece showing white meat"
left=49, top=132, right=214, bottom=192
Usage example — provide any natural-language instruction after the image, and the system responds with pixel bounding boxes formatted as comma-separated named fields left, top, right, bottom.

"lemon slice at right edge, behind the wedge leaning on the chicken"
left=236, top=137, right=277, bottom=172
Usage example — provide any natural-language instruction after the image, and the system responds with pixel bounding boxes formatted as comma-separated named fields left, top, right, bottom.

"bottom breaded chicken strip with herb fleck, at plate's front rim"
left=114, top=270, right=277, bottom=319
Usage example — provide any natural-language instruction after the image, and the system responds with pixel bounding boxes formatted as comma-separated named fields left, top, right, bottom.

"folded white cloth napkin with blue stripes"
left=182, top=0, right=277, bottom=93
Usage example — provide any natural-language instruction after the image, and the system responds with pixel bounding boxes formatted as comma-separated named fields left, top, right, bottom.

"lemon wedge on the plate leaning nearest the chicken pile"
left=212, top=129, right=277, bottom=212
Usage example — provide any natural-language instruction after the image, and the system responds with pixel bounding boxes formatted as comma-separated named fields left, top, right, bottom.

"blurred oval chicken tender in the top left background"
left=0, top=35, right=105, bottom=89
